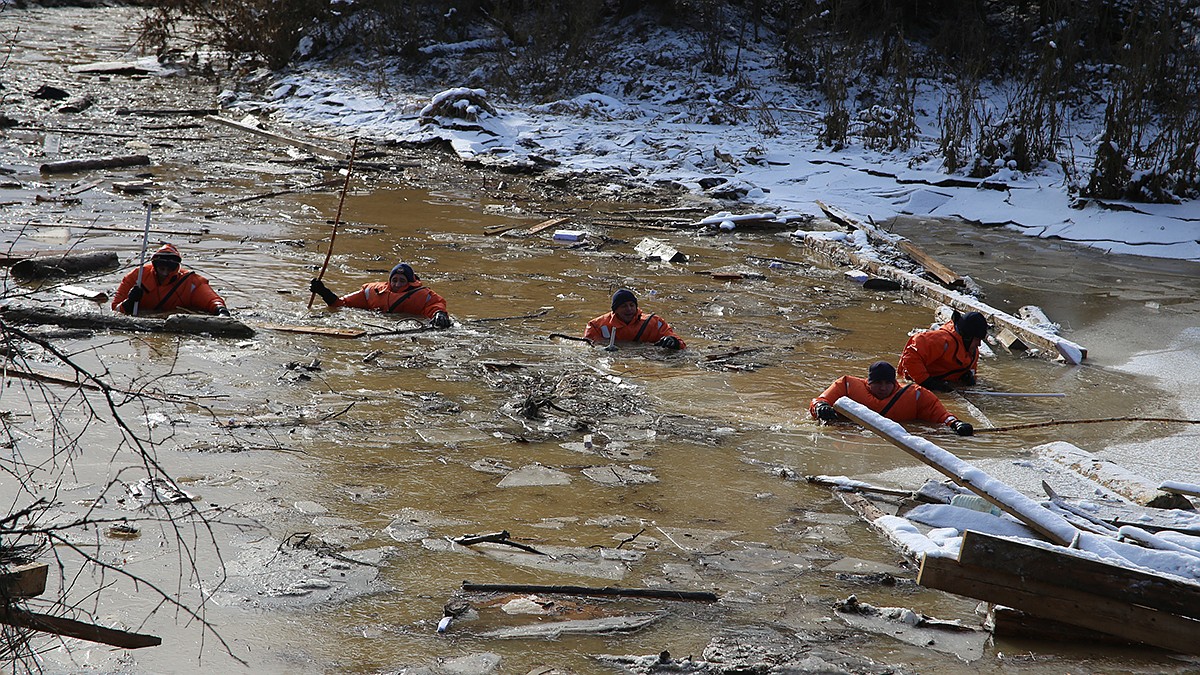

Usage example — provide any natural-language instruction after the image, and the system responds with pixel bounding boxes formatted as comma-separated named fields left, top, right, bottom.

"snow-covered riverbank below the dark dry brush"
left=226, top=15, right=1200, bottom=261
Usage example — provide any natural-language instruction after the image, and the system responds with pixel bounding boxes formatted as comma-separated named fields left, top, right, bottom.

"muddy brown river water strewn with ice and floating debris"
left=0, top=10, right=1200, bottom=673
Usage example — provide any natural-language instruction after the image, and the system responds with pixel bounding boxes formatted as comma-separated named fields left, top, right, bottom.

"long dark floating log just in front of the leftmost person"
left=0, top=305, right=254, bottom=338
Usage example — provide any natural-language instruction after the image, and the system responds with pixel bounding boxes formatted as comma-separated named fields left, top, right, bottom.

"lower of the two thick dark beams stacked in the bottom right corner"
left=917, top=556, right=1200, bottom=655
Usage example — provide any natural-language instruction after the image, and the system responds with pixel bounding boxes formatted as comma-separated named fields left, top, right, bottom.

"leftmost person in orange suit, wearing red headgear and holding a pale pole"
left=113, top=244, right=229, bottom=316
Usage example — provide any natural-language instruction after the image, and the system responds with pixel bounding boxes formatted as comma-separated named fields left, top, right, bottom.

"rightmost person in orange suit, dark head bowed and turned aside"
left=899, top=311, right=988, bottom=392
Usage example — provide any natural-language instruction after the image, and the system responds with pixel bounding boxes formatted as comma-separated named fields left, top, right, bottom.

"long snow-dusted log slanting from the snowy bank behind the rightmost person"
left=799, top=220, right=1087, bottom=365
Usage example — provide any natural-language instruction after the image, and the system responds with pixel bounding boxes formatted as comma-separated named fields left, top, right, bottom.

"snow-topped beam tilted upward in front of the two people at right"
left=833, top=396, right=1078, bottom=545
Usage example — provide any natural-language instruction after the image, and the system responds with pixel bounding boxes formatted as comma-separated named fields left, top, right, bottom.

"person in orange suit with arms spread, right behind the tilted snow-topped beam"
left=809, top=362, right=974, bottom=436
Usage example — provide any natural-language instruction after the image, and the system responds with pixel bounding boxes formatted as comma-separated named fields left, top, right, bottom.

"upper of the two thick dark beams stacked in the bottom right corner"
left=959, top=531, right=1200, bottom=619
